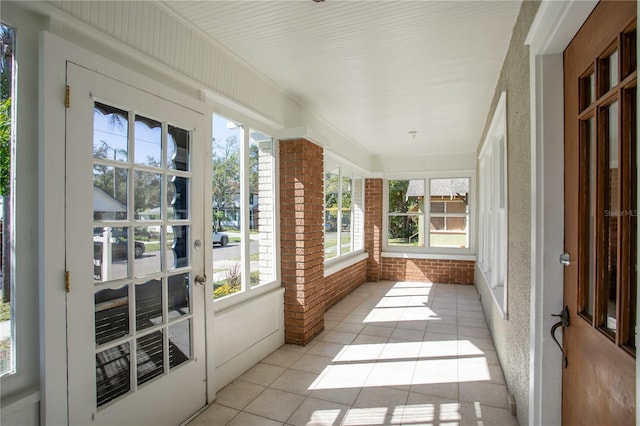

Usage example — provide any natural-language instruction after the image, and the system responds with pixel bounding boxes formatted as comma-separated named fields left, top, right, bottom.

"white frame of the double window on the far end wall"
left=382, top=169, right=476, bottom=261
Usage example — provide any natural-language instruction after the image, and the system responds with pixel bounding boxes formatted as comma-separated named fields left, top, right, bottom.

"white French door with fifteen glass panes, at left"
left=64, top=63, right=207, bottom=425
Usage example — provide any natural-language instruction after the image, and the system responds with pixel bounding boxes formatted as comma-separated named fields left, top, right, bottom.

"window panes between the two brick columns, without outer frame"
left=324, top=164, right=364, bottom=261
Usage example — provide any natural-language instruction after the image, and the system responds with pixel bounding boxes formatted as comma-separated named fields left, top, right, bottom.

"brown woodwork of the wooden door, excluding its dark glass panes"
left=562, top=2, right=637, bottom=425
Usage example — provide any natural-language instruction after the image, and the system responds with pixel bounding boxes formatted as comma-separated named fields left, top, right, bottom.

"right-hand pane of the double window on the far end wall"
left=429, top=178, right=469, bottom=248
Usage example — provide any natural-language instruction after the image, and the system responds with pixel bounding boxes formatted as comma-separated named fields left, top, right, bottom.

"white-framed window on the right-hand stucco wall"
left=478, top=92, right=508, bottom=319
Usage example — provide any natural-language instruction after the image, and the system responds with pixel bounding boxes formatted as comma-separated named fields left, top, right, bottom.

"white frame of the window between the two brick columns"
left=322, top=150, right=368, bottom=276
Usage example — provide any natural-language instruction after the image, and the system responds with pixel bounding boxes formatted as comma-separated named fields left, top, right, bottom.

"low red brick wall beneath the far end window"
left=382, top=257, right=475, bottom=284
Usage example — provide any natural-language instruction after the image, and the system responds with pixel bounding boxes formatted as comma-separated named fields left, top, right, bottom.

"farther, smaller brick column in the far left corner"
left=364, top=179, right=382, bottom=281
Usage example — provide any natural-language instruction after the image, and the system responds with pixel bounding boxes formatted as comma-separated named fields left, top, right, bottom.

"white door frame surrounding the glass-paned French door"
left=40, top=32, right=215, bottom=424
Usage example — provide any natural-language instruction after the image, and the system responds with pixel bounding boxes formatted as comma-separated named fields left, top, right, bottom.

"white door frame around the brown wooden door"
left=526, top=0, right=640, bottom=425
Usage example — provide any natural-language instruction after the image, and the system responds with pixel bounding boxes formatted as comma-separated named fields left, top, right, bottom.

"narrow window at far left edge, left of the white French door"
left=0, top=24, right=15, bottom=376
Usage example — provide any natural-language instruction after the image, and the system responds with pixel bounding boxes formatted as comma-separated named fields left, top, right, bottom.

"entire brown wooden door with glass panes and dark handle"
left=562, top=2, right=638, bottom=425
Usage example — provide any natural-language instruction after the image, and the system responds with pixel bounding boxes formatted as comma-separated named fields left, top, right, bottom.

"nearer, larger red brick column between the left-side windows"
left=280, top=139, right=325, bottom=345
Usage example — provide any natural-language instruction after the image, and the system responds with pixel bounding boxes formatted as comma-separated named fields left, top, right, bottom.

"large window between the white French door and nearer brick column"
left=211, top=115, right=276, bottom=299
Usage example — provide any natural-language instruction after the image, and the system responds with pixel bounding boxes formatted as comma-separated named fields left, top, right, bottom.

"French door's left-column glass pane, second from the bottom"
left=95, top=286, right=129, bottom=345
